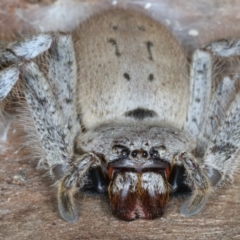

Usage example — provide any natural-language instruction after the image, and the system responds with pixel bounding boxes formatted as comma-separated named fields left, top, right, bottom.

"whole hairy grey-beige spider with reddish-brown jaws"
left=0, top=9, right=240, bottom=222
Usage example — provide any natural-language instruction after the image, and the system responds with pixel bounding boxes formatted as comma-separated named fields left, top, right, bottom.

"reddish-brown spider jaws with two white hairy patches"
left=108, top=171, right=170, bottom=221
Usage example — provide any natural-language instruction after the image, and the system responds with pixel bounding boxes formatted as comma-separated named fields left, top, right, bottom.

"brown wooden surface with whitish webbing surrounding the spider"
left=0, top=0, right=240, bottom=240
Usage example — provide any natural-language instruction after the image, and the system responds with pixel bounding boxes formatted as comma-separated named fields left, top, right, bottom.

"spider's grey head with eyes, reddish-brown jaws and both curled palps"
left=58, top=125, right=218, bottom=221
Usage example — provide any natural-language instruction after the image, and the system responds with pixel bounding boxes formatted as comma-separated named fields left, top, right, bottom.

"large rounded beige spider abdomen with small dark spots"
left=73, top=9, right=189, bottom=129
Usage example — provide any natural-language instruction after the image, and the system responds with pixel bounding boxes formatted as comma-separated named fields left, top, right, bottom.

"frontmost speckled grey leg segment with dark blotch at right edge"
left=204, top=87, right=240, bottom=182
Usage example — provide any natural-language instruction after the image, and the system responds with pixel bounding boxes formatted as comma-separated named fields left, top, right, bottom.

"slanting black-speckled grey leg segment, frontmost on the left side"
left=22, top=62, right=73, bottom=168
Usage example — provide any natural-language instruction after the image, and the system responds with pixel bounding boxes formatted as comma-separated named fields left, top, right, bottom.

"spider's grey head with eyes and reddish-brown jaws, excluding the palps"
left=78, top=125, right=197, bottom=221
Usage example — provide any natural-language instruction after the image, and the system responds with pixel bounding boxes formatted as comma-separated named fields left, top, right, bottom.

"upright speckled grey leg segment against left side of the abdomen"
left=44, top=34, right=80, bottom=144
